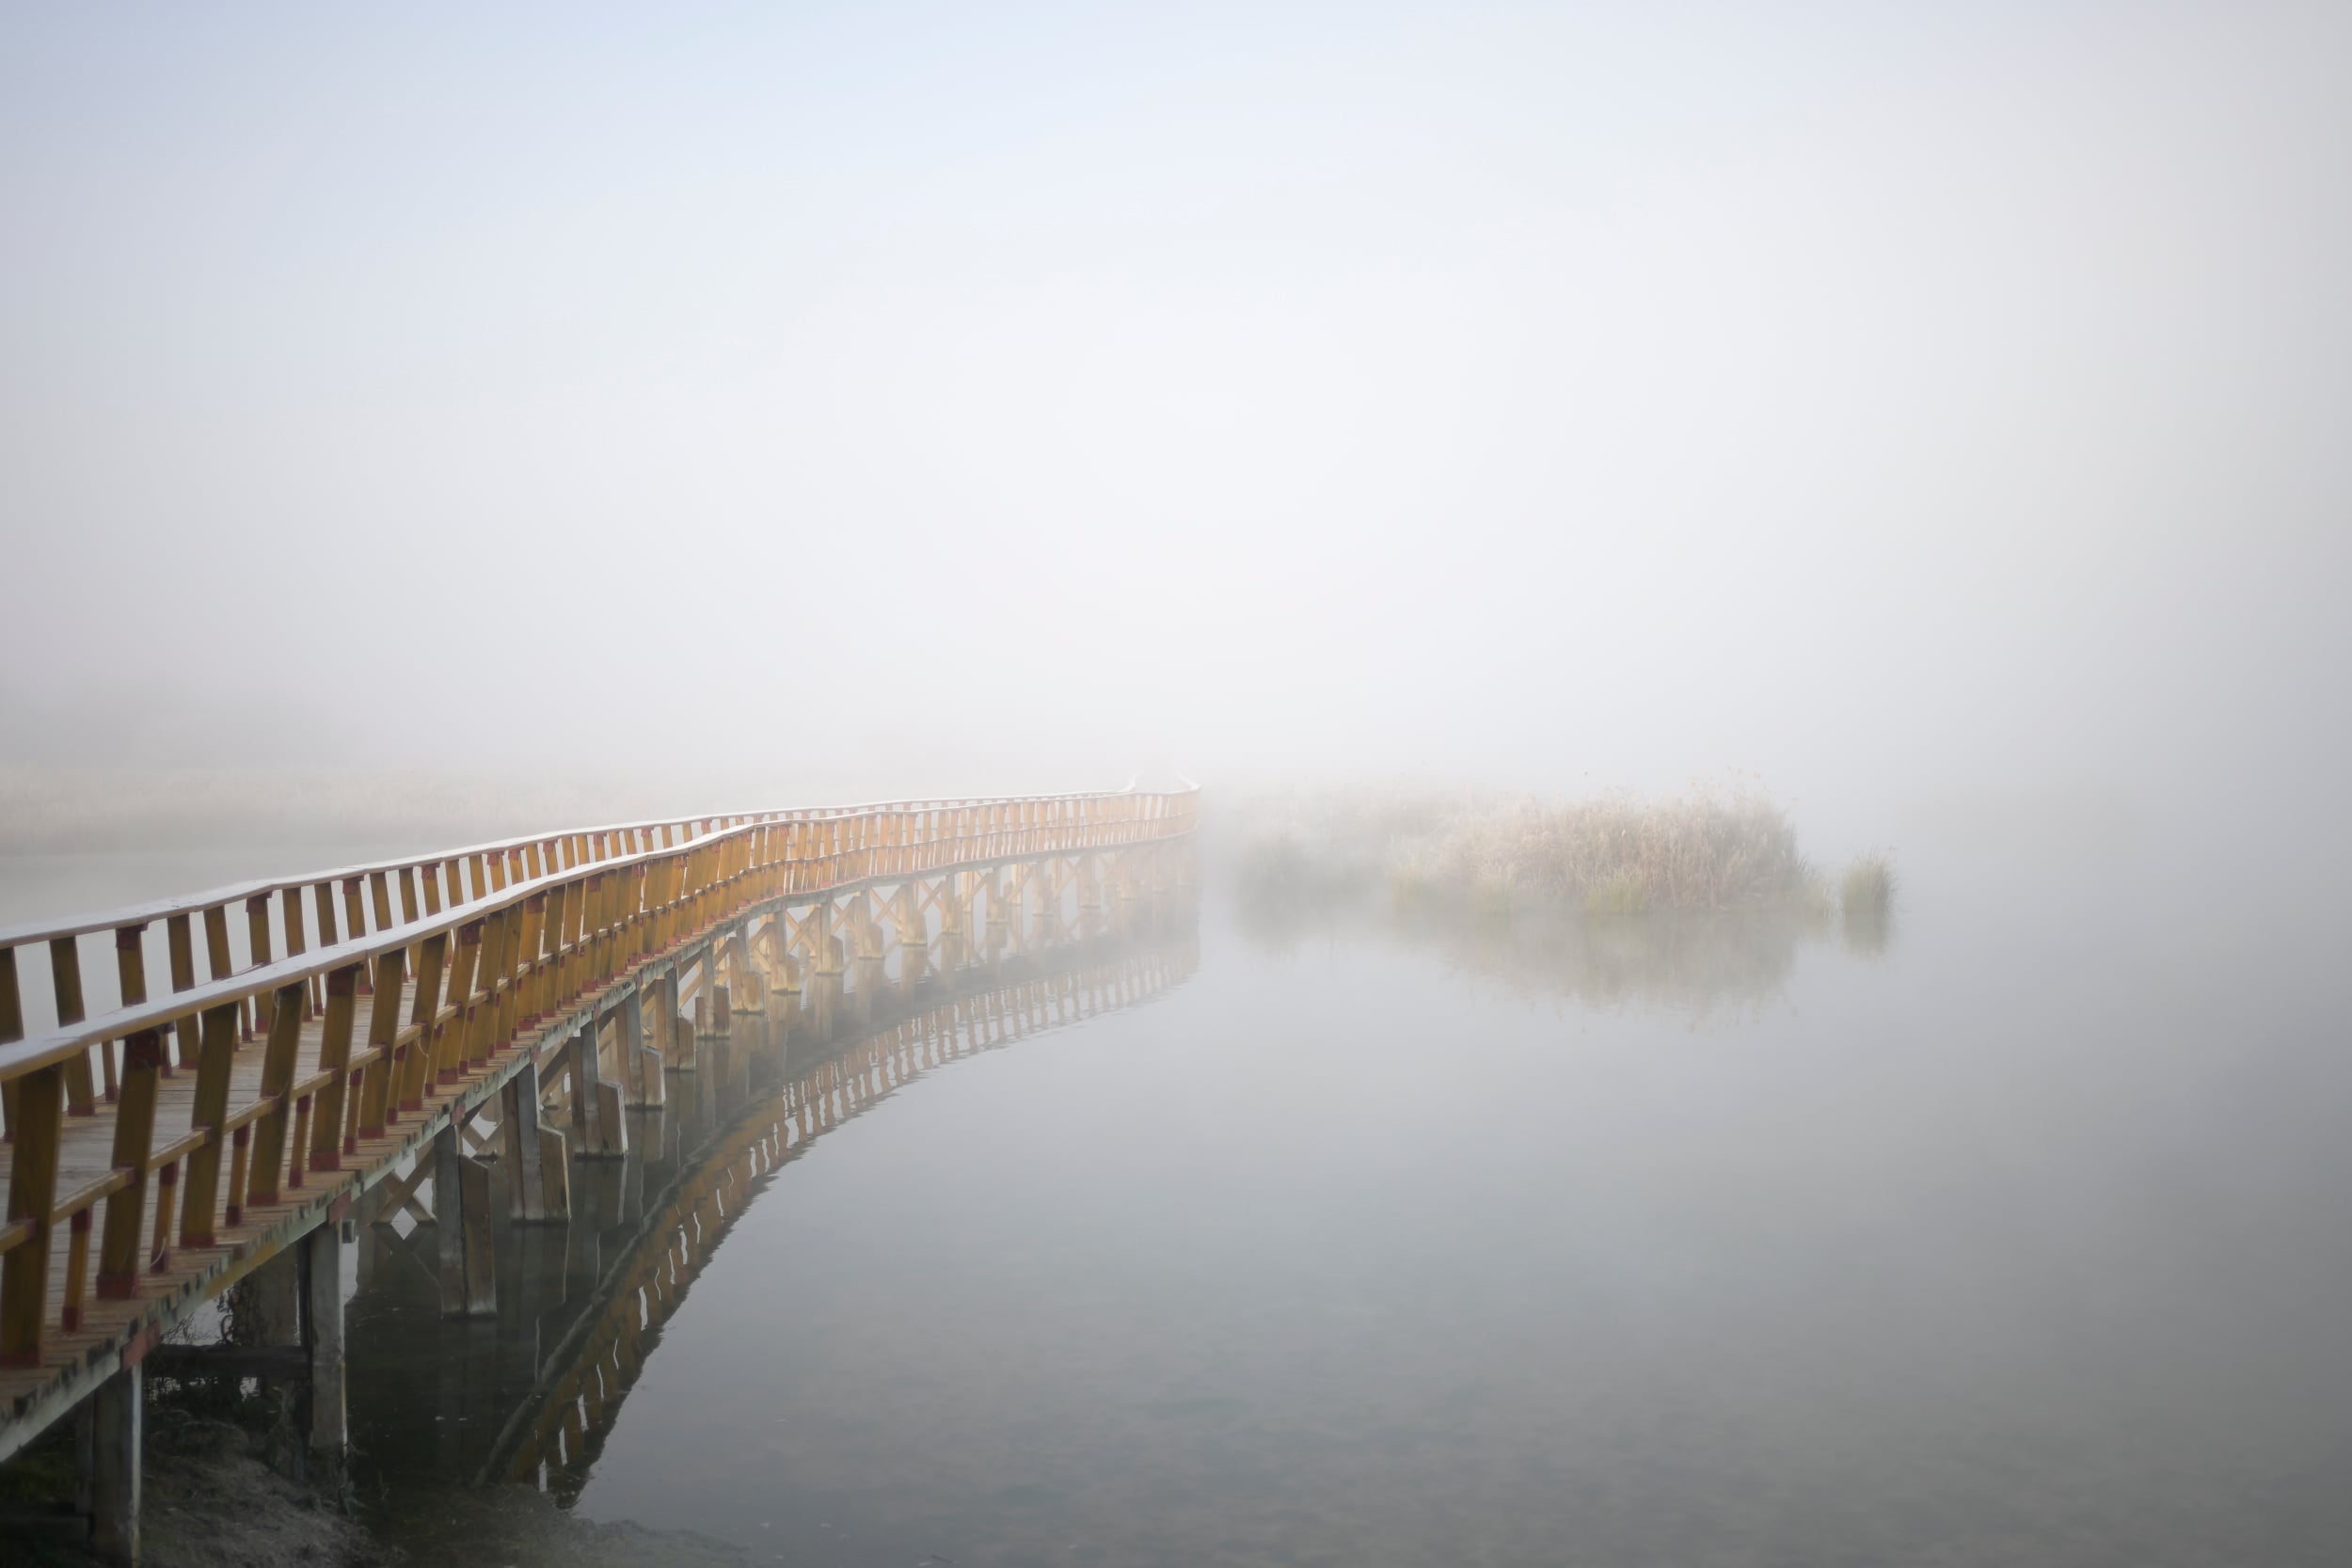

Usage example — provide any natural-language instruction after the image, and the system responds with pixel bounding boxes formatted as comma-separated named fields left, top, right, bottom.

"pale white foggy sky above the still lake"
left=0, top=5, right=2352, bottom=841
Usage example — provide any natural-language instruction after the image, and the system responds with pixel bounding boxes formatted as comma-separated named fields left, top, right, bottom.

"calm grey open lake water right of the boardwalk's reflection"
left=224, top=832, right=2352, bottom=1568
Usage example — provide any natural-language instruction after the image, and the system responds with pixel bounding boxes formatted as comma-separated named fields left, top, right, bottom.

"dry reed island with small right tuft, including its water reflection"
left=1214, top=787, right=1899, bottom=1011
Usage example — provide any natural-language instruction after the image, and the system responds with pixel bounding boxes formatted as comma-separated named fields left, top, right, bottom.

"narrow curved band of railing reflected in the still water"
left=478, top=931, right=1200, bottom=1496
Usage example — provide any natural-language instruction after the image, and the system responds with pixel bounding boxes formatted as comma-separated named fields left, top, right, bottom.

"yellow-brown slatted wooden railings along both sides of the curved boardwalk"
left=0, top=790, right=1195, bottom=1369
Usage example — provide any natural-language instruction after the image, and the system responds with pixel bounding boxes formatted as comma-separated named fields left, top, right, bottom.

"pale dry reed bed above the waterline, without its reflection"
left=1240, top=790, right=1825, bottom=914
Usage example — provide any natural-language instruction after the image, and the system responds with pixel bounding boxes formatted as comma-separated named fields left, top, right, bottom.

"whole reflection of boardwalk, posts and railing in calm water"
left=351, top=891, right=1198, bottom=1502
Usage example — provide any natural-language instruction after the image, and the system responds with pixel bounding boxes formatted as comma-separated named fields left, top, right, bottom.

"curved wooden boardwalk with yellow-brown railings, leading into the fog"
left=0, top=790, right=1198, bottom=1458
